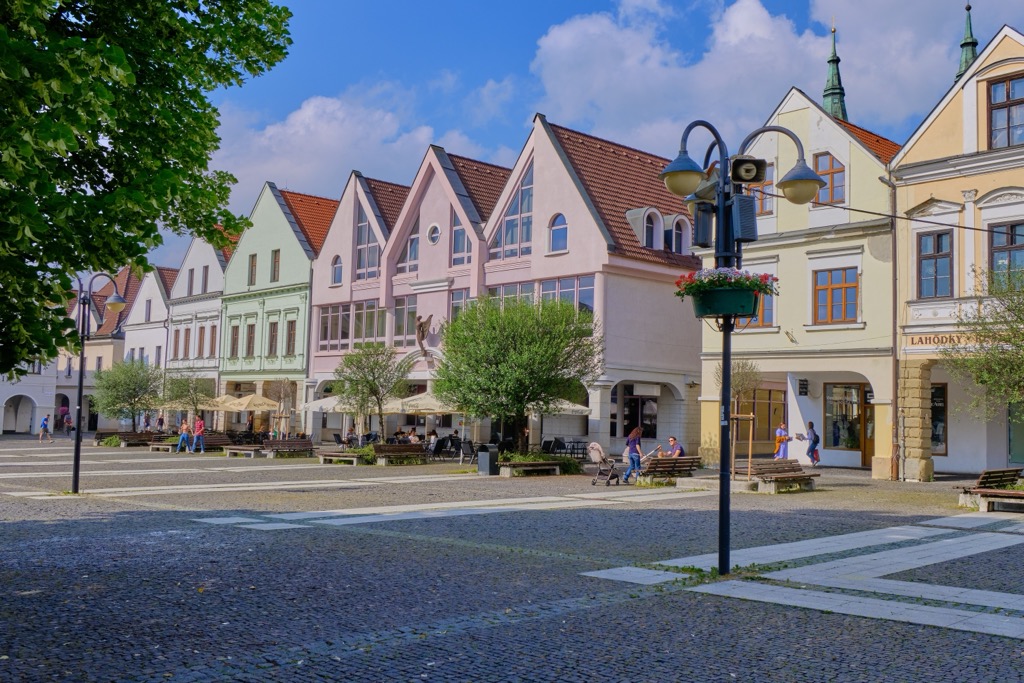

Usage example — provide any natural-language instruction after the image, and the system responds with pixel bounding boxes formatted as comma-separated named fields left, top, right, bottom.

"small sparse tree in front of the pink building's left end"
left=332, top=343, right=414, bottom=436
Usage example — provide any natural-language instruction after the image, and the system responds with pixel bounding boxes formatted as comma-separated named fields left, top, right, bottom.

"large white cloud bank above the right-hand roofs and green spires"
left=530, top=0, right=1024, bottom=157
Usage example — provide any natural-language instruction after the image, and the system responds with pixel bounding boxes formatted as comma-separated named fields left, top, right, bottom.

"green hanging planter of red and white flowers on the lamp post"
left=676, top=268, right=778, bottom=317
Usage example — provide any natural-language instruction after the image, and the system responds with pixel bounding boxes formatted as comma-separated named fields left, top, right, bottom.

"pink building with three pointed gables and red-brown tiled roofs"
left=306, top=115, right=700, bottom=453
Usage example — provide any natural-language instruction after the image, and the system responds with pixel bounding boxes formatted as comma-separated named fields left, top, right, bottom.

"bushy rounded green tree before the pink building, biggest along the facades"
left=434, top=297, right=604, bottom=453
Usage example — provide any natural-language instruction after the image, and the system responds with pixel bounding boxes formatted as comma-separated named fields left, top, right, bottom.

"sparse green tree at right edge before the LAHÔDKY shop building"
left=939, top=269, right=1024, bottom=417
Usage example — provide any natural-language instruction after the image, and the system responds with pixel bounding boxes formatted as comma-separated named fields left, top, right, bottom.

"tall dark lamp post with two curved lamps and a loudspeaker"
left=658, top=121, right=826, bottom=575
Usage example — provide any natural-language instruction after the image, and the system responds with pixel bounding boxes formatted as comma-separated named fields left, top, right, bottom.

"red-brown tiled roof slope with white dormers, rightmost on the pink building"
left=548, top=124, right=700, bottom=268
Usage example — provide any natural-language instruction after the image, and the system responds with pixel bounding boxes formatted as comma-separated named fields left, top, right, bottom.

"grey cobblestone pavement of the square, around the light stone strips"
left=0, top=437, right=1024, bottom=682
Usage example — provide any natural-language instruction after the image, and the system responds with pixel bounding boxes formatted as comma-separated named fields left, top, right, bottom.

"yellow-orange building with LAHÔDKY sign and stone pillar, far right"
left=892, top=24, right=1024, bottom=480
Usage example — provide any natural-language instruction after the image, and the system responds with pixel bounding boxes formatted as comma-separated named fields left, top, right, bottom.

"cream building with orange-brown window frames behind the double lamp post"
left=700, top=37, right=899, bottom=478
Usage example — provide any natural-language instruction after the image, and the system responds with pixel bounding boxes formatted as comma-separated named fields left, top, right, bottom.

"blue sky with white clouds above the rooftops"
left=153, top=0, right=1024, bottom=267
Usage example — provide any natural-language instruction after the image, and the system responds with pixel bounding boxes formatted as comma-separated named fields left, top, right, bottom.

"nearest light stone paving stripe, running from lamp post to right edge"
left=687, top=581, right=1024, bottom=639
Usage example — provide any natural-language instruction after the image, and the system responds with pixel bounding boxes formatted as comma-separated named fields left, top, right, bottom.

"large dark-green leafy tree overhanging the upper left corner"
left=0, top=0, right=291, bottom=375
